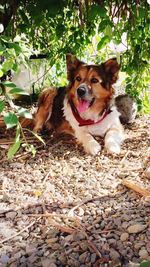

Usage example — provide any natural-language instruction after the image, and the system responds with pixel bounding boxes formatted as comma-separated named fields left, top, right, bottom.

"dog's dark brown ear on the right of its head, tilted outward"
left=100, top=58, right=120, bottom=89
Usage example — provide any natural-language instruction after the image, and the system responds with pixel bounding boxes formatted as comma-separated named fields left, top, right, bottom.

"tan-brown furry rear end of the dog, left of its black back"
left=33, top=87, right=57, bottom=132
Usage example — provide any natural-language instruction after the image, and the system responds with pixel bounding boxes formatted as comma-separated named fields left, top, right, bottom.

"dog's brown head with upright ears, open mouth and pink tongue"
left=66, top=54, right=120, bottom=114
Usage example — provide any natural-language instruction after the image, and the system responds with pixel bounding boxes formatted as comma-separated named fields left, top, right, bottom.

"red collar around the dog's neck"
left=69, top=100, right=111, bottom=127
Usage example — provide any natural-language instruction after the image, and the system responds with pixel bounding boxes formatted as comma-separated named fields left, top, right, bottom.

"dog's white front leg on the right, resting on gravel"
left=105, top=125, right=124, bottom=154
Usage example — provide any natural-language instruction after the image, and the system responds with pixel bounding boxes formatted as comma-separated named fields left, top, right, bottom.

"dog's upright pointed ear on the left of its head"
left=66, top=54, right=84, bottom=81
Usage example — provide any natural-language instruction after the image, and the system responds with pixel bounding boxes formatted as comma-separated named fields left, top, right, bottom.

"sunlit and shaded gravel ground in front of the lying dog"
left=0, top=116, right=150, bottom=267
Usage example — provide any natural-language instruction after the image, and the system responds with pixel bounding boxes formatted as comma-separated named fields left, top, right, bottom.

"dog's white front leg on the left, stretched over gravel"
left=75, top=129, right=101, bottom=155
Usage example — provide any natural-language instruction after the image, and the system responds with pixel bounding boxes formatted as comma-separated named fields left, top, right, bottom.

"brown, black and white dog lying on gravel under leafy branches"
left=34, top=54, right=124, bottom=155
